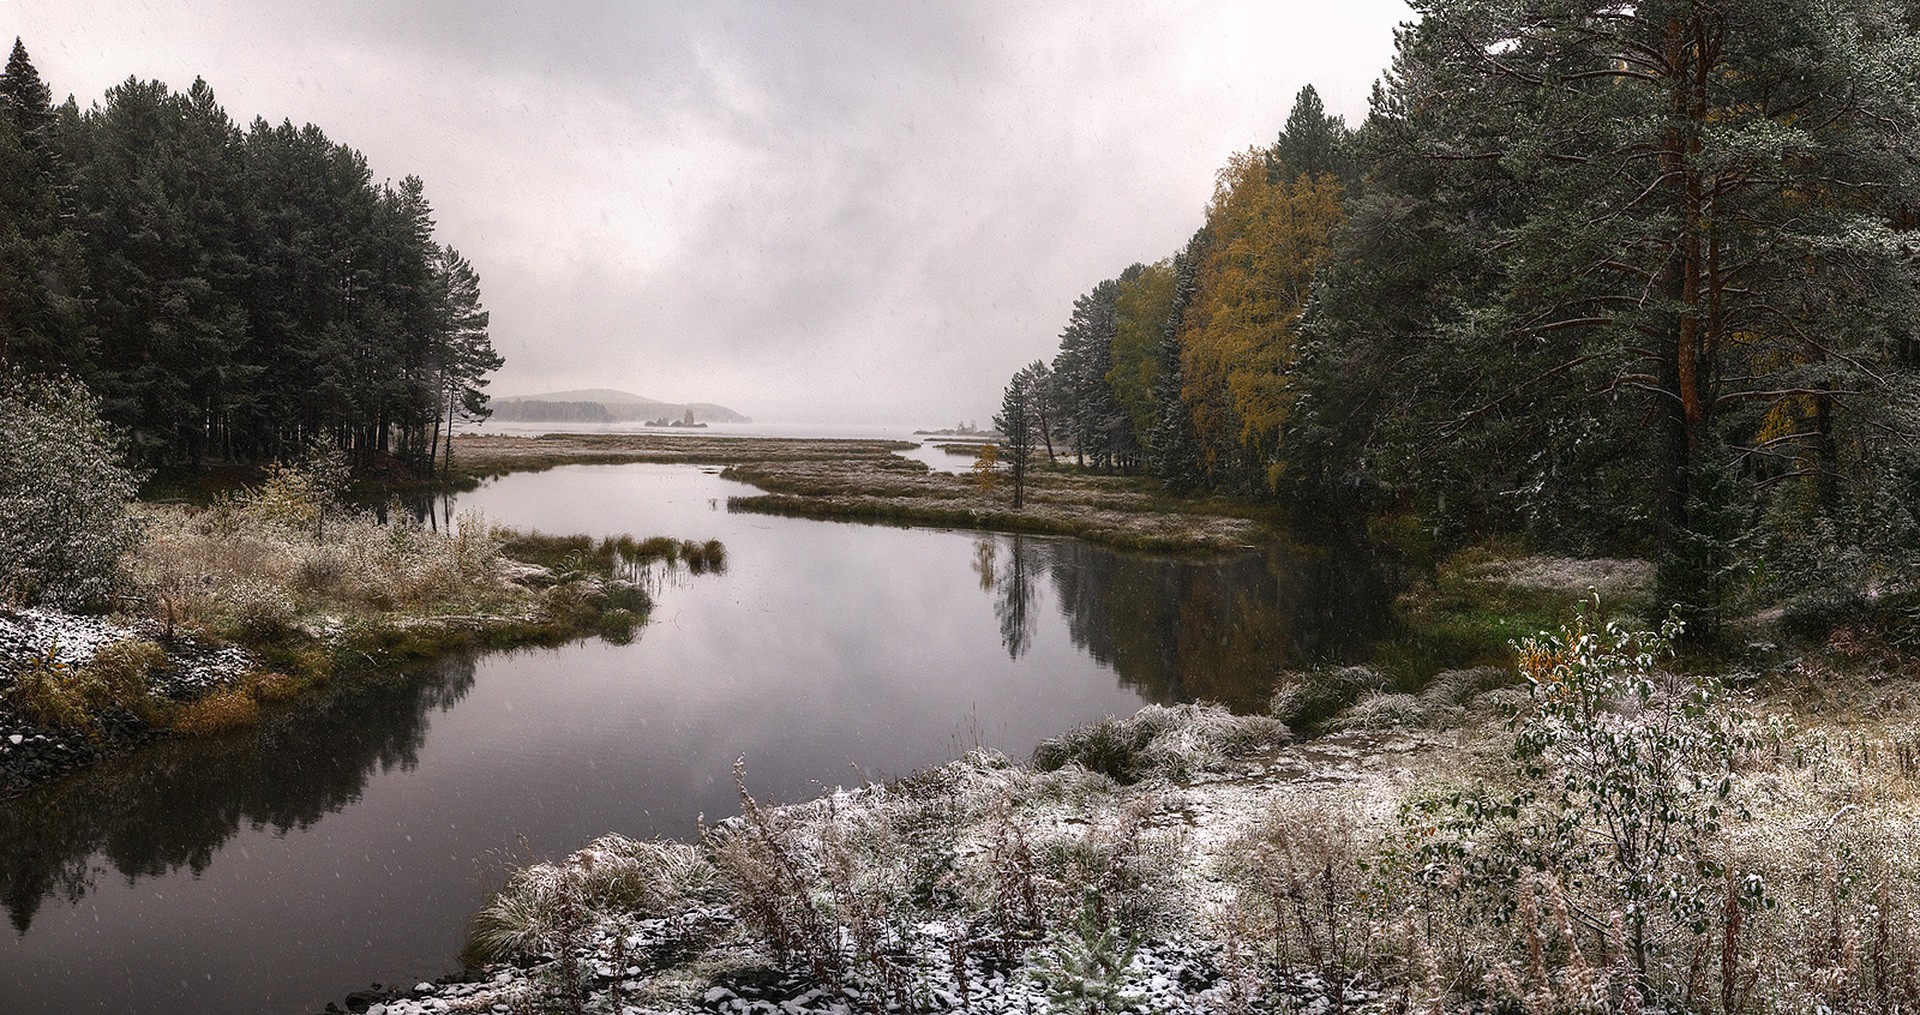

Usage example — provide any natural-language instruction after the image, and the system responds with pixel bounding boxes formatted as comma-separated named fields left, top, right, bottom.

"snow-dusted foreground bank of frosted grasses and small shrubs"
left=345, top=606, right=1920, bottom=1015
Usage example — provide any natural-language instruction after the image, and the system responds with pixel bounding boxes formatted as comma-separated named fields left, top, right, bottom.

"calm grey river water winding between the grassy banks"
left=0, top=466, right=1386, bottom=1013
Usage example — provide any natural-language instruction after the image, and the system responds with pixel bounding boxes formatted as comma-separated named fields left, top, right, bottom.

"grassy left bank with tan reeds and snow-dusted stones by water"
left=0, top=499, right=726, bottom=798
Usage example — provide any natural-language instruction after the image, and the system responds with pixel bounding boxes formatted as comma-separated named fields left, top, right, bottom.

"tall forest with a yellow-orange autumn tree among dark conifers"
left=1006, top=0, right=1920, bottom=621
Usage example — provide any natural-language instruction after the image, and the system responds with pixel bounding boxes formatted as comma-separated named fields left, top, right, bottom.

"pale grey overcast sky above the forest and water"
left=0, top=0, right=1409, bottom=424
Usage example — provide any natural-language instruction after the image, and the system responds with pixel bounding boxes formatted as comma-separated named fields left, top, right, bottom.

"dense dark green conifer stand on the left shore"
left=0, top=40, right=501, bottom=466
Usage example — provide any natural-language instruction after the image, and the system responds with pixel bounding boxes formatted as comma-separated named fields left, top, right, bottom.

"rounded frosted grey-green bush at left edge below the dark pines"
left=0, top=374, right=140, bottom=606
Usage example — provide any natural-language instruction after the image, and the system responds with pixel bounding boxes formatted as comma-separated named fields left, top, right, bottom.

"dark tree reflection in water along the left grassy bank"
left=0, top=658, right=474, bottom=934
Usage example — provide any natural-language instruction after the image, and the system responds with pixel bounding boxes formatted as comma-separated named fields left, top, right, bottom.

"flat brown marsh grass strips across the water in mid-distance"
left=441, top=434, right=1271, bottom=553
